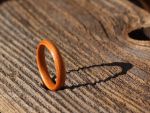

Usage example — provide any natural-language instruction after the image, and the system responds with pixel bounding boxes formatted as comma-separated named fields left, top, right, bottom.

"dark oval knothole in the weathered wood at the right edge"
left=129, top=28, right=150, bottom=41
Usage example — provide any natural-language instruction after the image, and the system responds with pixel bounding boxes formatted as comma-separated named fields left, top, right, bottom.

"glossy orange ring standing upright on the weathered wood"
left=36, top=39, right=66, bottom=91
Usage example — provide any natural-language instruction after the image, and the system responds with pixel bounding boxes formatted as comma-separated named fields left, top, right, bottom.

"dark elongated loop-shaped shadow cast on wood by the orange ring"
left=60, top=62, right=133, bottom=90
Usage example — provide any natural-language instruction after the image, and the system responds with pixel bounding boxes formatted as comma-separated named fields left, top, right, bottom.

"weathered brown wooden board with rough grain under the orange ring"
left=0, top=0, right=150, bottom=113
